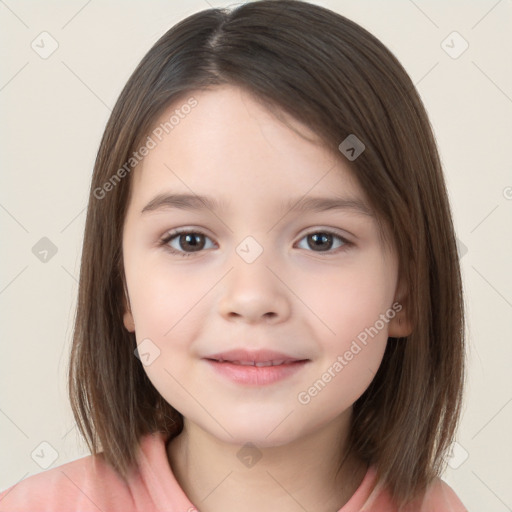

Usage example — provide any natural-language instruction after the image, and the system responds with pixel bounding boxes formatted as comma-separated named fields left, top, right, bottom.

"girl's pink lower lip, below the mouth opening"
left=206, top=359, right=309, bottom=386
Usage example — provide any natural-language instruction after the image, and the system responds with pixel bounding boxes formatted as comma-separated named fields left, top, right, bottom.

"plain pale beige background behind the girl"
left=0, top=0, right=512, bottom=512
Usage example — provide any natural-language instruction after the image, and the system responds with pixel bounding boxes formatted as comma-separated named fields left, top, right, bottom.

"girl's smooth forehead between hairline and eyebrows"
left=128, top=85, right=364, bottom=209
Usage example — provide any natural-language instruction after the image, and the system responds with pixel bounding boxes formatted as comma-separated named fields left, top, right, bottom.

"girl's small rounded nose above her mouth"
left=219, top=251, right=291, bottom=324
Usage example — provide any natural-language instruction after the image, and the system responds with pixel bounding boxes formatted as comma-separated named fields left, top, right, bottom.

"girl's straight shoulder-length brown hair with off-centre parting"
left=68, top=0, right=464, bottom=504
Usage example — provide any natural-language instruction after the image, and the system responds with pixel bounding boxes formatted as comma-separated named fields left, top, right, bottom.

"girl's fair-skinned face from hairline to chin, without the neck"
left=123, top=86, right=406, bottom=446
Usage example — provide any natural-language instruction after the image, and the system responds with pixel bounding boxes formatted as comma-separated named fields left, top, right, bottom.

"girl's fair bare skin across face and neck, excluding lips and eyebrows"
left=123, top=85, right=409, bottom=512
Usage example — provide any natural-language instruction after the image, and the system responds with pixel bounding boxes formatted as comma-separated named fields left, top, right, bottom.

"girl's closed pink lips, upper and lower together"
left=205, top=349, right=309, bottom=386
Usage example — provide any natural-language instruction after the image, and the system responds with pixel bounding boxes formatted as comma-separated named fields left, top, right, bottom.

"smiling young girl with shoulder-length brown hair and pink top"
left=0, top=0, right=465, bottom=512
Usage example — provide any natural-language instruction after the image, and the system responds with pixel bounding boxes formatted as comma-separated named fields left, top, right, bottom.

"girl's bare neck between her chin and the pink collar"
left=167, top=413, right=367, bottom=512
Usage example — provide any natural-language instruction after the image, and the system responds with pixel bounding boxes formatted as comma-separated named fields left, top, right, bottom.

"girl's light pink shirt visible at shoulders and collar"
left=0, top=433, right=467, bottom=512
